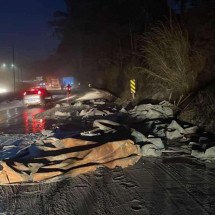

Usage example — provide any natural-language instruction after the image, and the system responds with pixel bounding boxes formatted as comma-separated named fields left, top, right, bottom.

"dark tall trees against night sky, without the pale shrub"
left=33, top=0, right=214, bottom=97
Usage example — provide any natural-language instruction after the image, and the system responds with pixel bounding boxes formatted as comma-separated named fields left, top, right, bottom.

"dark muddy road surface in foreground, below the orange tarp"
left=0, top=157, right=215, bottom=215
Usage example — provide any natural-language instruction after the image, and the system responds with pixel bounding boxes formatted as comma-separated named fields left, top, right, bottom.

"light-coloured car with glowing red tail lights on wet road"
left=23, top=88, right=52, bottom=107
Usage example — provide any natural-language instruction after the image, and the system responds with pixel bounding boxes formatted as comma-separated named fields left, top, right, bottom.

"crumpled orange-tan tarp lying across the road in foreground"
left=0, top=138, right=141, bottom=185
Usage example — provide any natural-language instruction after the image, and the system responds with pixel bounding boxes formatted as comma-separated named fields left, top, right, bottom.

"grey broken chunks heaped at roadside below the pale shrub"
left=81, top=102, right=215, bottom=160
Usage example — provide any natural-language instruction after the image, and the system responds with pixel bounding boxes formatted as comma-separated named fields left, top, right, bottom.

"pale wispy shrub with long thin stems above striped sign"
left=133, top=25, right=205, bottom=99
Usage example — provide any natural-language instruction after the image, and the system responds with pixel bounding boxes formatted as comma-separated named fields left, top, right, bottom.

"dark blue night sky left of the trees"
left=0, top=0, right=65, bottom=63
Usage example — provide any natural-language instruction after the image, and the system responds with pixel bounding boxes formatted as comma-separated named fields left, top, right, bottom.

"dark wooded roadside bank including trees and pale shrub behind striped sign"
left=37, top=0, right=215, bottom=131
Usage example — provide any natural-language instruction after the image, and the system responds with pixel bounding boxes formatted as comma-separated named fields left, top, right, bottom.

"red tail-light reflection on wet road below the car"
left=22, top=108, right=46, bottom=133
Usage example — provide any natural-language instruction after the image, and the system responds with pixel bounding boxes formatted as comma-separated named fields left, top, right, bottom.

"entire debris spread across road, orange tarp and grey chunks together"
left=0, top=90, right=215, bottom=184
